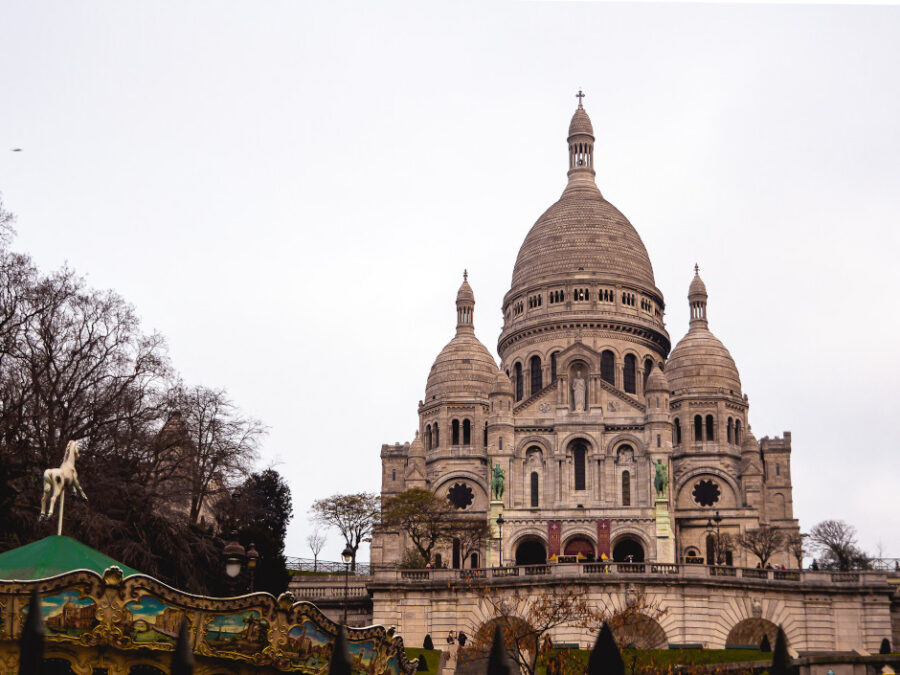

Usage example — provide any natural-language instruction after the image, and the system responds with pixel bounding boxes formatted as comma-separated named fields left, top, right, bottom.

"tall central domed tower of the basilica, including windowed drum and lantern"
left=498, top=97, right=670, bottom=409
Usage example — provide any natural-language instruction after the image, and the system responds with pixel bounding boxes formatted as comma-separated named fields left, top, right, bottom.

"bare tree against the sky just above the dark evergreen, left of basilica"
left=161, top=385, right=266, bottom=524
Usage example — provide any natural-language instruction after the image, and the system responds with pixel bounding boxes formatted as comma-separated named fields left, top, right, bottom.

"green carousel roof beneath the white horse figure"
left=0, top=536, right=141, bottom=581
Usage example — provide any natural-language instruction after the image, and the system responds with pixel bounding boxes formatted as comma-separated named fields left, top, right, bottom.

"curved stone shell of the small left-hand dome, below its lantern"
left=425, top=331, right=498, bottom=403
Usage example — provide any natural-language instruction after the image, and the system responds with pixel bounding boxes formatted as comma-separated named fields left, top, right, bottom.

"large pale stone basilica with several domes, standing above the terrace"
left=371, top=97, right=798, bottom=569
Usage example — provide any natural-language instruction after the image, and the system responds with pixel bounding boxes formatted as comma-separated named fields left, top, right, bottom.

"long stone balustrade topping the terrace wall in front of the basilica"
left=370, top=562, right=886, bottom=586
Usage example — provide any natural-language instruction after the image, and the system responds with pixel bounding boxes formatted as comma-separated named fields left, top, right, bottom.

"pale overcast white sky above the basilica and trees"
left=0, top=0, right=900, bottom=559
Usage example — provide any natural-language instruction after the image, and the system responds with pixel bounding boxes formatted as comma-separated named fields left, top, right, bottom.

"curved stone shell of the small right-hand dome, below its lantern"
left=666, top=325, right=741, bottom=396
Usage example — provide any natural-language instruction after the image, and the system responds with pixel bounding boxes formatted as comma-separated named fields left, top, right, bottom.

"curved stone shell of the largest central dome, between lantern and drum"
left=512, top=182, right=656, bottom=292
